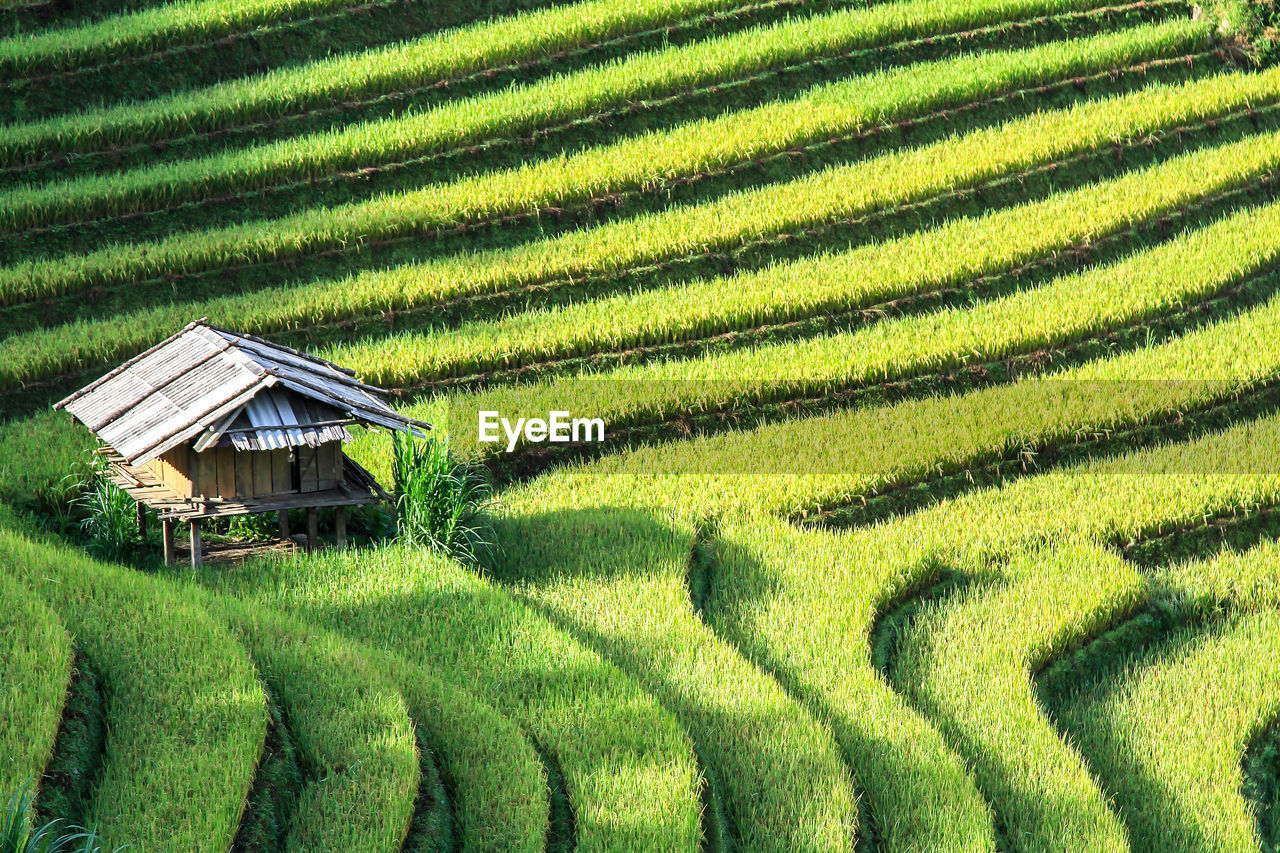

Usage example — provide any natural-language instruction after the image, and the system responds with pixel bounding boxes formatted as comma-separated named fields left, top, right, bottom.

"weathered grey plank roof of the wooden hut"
left=54, top=320, right=431, bottom=465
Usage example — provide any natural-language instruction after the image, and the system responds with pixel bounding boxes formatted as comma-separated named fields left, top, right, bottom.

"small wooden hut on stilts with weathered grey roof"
left=54, top=320, right=430, bottom=565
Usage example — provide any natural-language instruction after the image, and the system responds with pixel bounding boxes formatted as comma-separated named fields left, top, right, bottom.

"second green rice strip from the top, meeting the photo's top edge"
left=0, top=0, right=814, bottom=166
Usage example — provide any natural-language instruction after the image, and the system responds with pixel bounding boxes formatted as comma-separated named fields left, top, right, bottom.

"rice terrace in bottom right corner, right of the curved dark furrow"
left=1059, top=543, right=1280, bottom=852
